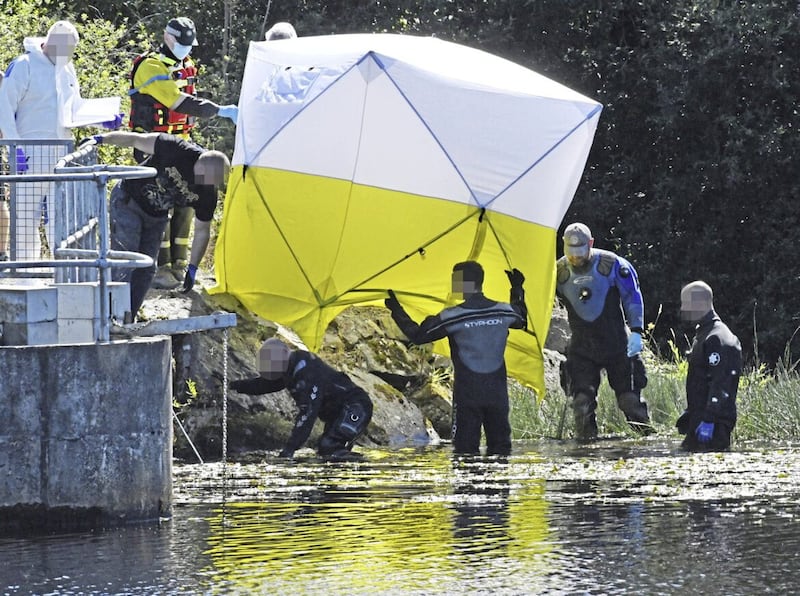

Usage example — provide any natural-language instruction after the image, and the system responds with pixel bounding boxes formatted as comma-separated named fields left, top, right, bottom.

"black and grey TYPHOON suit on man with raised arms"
left=387, top=288, right=527, bottom=455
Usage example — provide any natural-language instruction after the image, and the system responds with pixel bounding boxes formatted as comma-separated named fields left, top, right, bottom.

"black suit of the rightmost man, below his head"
left=676, top=310, right=742, bottom=451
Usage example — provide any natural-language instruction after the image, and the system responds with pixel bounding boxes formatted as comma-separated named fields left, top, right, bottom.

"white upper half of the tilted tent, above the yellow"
left=233, top=34, right=601, bottom=228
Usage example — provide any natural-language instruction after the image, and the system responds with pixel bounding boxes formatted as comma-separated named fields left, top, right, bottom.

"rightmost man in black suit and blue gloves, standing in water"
left=675, top=281, right=742, bottom=451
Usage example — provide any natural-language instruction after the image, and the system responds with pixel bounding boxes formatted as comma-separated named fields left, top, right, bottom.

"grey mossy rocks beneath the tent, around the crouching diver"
left=136, top=277, right=564, bottom=461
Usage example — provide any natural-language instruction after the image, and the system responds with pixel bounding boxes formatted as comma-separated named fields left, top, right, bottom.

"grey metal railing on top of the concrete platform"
left=0, top=139, right=156, bottom=342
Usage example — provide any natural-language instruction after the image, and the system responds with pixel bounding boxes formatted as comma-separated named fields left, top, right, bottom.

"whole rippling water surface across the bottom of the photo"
left=0, top=441, right=800, bottom=595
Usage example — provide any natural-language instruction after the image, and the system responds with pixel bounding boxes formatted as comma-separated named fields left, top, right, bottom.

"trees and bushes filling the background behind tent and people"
left=6, top=0, right=800, bottom=378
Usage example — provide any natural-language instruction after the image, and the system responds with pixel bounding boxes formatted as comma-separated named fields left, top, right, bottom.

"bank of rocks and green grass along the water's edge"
left=143, top=274, right=800, bottom=461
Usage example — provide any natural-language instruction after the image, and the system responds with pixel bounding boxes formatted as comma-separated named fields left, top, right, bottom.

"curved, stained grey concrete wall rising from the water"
left=0, top=336, right=172, bottom=526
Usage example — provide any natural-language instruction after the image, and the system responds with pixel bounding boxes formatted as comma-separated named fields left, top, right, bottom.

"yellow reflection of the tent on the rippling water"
left=202, top=452, right=550, bottom=593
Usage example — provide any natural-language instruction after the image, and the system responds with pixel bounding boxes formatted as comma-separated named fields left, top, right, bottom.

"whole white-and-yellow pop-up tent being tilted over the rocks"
left=214, top=35, right=601, bottom=395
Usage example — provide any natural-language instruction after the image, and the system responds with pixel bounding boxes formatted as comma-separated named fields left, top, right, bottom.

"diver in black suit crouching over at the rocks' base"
left=229, top=337, right=372, bottom=460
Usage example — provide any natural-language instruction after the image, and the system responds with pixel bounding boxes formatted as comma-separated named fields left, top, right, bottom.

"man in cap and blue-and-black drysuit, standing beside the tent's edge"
left=556, top=223, right=652, bottom=440
